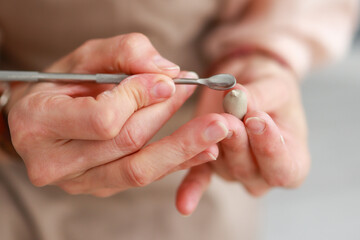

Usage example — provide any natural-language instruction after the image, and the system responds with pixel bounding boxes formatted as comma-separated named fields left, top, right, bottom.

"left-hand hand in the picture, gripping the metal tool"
left=9, top=34, right=231, bottom=196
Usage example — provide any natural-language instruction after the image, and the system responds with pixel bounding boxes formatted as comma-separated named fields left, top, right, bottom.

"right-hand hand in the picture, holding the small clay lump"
left=177, top=55, right=310, bottom=214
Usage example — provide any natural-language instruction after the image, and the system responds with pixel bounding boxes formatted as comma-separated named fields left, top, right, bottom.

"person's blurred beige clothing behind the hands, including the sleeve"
left=0, top=0, right=358, bottom=240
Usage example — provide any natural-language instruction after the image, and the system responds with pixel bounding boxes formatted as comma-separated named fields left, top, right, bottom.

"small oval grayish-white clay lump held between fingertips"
left=223, top=89, right=247, bottom=119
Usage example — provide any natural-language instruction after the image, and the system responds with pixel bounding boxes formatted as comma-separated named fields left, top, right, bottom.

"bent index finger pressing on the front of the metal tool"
left=36, top=74, right=175, bottom=140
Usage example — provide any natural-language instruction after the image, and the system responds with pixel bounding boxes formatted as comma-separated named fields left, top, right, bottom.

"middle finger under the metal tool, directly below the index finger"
left=49, top=72, right=195, bottom=176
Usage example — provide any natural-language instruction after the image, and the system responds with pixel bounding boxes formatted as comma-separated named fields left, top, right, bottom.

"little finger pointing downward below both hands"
left=176, top=164, right=212, bottom=216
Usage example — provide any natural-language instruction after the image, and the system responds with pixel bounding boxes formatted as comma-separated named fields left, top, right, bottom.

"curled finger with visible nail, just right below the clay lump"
left=245, top=112, right=298, bottom=187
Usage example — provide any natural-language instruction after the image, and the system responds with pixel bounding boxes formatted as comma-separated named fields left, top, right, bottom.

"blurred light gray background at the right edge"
left=261, top=43, right=360, bottom=240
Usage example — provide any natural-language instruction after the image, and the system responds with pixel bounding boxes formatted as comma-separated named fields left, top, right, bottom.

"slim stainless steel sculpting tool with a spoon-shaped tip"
left=0, top=71, right=236, bottom=91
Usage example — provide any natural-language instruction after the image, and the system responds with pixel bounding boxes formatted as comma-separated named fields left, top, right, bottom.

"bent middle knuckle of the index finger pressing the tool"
left=90, top=108, right=120, bottom=140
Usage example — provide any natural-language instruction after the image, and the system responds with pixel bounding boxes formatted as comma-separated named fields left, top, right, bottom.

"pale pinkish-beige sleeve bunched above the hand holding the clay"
left=204, top=0, right=359, bottom=76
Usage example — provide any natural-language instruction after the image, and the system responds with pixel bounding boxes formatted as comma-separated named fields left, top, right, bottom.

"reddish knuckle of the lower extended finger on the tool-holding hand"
left=126, top=160, right=152, bottom=187
